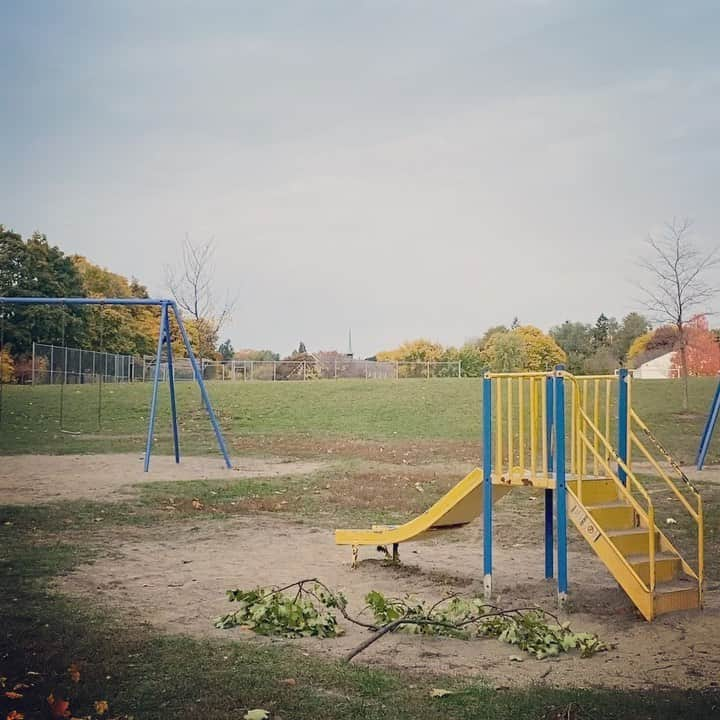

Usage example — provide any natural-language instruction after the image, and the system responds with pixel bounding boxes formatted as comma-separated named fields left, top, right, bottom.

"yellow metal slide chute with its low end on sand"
left=335, top=468, right=511, bottom=559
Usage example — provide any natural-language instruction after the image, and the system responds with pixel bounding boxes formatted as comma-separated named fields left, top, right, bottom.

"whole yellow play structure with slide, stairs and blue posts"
left=335, top=368, right=704, bottom=620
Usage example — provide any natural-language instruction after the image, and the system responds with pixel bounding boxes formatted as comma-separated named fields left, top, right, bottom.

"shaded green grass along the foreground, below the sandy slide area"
left=0, top=508, right=720, bottom=720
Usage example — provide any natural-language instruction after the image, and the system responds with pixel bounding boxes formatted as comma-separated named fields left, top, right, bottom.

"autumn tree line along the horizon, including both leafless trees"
left=0, top=219, right=720, bottom=405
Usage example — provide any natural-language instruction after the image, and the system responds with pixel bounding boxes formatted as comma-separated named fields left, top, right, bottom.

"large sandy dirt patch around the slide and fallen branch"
left=61, top=515, right=720, bottom=688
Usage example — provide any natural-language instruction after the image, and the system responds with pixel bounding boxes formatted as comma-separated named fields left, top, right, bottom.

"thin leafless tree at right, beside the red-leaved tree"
left=640, top=218, right=720, bottom=410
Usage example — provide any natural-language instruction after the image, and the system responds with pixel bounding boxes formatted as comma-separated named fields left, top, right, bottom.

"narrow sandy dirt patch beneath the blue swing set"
left=0, top=454, right=323, bottom=505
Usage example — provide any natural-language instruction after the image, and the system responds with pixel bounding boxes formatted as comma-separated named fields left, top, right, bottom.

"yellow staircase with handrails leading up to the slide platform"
left=565, top=374, right=703, bottom=620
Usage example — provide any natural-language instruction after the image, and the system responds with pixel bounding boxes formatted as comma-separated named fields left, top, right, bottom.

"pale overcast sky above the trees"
left=0, top=0, right=720, bottom=355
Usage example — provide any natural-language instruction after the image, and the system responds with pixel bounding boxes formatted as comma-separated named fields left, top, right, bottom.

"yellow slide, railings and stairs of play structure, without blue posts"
left=335, top=370, right=704, bottom=620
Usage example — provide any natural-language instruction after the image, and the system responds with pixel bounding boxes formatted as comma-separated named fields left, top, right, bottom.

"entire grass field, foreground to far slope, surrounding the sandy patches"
left=0, top=379, right=720, bottom=720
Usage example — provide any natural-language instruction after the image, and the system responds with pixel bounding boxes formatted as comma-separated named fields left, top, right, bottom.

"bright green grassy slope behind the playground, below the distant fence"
left=0, top=378, right=720, bottom=462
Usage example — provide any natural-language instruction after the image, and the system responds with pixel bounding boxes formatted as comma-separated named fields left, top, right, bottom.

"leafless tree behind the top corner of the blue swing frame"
left=165, top=235, right=236, bottom=357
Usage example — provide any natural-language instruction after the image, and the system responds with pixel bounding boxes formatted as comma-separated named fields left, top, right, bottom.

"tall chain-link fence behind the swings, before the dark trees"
left=32, top=343, right=138, bottom=385
